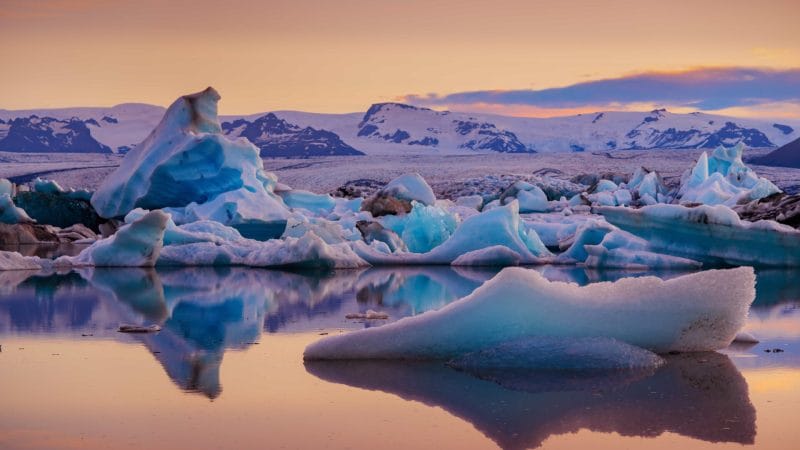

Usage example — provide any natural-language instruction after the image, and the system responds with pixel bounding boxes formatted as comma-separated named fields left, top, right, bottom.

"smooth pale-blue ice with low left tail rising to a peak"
left=353, top=201, right=552, bottom=265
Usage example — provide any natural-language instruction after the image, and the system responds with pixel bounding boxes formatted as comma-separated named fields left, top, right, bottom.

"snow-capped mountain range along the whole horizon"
left=0, top=103, right=800, bottom=157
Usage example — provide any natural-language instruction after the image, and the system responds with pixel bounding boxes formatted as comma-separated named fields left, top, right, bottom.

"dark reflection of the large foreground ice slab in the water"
left=306, top=353, right=756, bottom=449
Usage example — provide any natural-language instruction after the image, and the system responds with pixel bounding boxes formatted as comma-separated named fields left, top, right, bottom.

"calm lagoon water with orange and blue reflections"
left=0, top=267, right=800, bottom=450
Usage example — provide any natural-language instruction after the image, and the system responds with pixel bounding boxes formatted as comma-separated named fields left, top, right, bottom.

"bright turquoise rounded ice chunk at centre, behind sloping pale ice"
left=380, top=201, right=458, bottom=253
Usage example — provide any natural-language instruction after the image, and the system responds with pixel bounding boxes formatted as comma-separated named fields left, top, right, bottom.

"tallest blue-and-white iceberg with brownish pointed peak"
left=92, top=88, right=289, bottom=237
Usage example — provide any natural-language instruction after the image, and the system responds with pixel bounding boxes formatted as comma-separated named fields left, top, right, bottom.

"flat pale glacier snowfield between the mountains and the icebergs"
left=0, top=148, right=800, bottom=199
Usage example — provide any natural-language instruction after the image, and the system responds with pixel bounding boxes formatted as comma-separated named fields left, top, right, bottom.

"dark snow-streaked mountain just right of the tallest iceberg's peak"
left=222, top=113, right=364, bottom=157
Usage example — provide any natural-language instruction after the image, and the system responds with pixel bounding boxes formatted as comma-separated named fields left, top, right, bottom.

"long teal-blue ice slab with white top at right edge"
left=598, top=205, right=800, bottom=267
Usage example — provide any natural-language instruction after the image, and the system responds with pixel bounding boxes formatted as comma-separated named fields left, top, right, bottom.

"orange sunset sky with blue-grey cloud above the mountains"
left=0, top=0, right=800, bottom=118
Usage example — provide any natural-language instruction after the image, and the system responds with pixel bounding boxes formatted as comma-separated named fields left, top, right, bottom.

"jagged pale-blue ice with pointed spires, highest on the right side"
left=678, top=143, right=781, bottom=206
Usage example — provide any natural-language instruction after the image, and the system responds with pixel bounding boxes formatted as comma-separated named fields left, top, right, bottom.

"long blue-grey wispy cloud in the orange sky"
left=403, top=67, right=800, bottom=115
